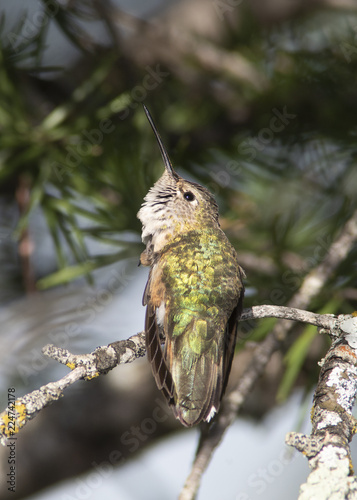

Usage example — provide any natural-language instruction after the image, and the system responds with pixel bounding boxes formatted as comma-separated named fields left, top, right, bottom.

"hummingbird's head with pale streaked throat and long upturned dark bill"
left=138, top=106, right=219, bottom=251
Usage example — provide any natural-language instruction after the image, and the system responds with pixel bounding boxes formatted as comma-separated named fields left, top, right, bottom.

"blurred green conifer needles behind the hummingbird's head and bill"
left=0, top=0, right=357, bottom=398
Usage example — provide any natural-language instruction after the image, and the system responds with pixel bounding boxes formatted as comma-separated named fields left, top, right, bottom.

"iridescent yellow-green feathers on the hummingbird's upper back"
left=158, top=228, right=242, bottom=336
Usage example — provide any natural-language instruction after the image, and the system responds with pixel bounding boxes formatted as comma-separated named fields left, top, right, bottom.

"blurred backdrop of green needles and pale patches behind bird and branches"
left=0, top=0, right=357, bottom=500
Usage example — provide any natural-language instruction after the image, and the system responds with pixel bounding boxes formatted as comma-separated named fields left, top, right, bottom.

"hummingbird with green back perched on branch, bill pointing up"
left=137, top=106, right=245, bottom=427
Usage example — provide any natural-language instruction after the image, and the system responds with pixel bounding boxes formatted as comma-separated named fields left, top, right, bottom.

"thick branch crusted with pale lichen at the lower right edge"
left=286, top=317, right=357, bottom=500
